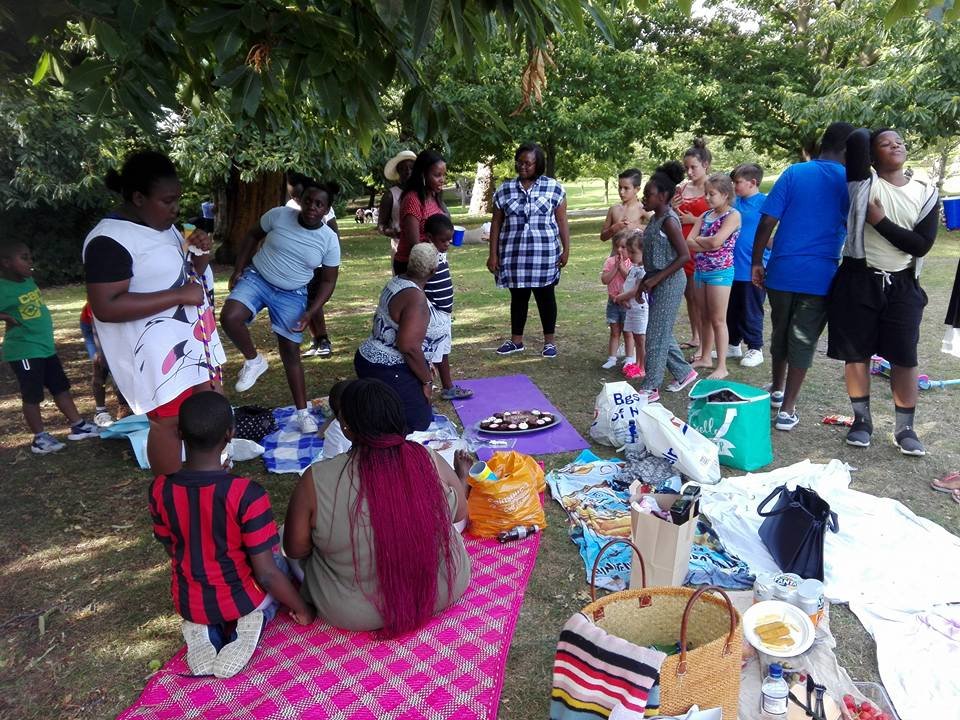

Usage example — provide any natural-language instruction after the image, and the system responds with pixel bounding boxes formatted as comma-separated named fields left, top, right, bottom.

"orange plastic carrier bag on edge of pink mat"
left=467, top=450, right=547, bottom=537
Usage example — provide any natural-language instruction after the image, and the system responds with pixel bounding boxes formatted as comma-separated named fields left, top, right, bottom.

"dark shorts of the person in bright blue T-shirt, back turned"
left=767, top=289, right=827, bottom=370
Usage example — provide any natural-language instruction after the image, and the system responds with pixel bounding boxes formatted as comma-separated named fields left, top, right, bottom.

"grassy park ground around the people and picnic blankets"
left=0, top=218, right=960, bottom=720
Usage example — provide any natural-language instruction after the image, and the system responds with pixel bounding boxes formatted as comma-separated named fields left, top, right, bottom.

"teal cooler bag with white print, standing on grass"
left=687, top=380, right=773, bottom=470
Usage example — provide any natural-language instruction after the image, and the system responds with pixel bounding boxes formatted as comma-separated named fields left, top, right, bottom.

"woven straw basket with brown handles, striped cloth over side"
left=583, top=539, right=743, bottom=720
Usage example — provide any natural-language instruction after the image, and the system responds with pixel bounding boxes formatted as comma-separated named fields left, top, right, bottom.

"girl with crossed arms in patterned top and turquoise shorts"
left=687, top=173, right=740, bottom=380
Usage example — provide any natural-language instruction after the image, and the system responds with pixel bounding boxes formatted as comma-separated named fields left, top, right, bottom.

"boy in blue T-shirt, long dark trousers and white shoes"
left=727, top=163, right=770, bottom=367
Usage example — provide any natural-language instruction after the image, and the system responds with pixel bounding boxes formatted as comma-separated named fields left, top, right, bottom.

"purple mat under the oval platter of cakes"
left=453, top=375, right=590, bottom=460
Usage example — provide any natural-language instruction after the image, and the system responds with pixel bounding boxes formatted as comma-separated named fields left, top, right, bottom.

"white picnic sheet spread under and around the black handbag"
left=700, top=460, right=960, bottom=720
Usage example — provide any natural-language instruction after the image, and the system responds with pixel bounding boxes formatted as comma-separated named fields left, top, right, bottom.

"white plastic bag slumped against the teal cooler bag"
left=637, top=403, right=720, bottom=485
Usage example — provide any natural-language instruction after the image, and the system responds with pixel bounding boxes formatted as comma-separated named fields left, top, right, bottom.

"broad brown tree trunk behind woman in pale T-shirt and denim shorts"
left=215, top=166, right=286, bottom=265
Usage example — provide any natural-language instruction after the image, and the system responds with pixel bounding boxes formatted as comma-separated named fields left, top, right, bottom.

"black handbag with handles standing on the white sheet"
left=757, top=485, right=840, bottom=580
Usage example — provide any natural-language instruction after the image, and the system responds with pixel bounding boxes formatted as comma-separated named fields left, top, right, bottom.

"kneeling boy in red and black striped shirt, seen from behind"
left=150, top=392, right=315, bottom=677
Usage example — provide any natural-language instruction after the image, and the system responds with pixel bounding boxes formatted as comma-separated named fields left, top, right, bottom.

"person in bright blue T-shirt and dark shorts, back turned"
left=752, top=122, right=853, bottom=430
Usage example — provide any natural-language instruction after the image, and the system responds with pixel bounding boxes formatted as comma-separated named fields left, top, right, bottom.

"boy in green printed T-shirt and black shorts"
left=0, top=242, right=98, bottom=455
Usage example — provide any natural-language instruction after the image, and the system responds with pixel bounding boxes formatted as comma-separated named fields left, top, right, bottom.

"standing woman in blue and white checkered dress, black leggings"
left=487, top=143, right=570, bottom=358
